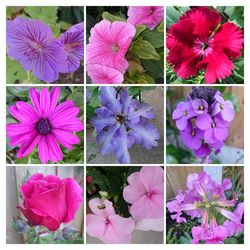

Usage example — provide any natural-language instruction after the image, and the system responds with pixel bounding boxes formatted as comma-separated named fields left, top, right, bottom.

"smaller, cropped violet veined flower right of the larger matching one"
left=57, top=22, right=84, bottom=73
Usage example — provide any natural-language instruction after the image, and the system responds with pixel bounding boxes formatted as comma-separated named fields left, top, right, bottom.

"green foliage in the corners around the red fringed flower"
left=166, top=6, right=244, bottom=84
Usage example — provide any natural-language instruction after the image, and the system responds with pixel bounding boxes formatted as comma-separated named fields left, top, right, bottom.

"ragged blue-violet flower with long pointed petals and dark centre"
left=92, top=86, right=160, bottom=163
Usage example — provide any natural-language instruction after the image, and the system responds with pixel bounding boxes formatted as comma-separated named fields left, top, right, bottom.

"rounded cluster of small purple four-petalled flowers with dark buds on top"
left=172, top=87, right=235, bottom=158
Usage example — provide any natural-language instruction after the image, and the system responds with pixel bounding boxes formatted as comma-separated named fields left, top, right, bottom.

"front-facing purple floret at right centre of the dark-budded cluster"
left=196, top=114, right=229, bottom=143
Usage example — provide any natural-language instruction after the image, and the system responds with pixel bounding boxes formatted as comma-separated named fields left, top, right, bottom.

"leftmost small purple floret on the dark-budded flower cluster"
left=172, top=102, right=195, bottom=130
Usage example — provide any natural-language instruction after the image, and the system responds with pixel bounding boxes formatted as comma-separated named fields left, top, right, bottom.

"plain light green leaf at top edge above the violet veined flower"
left=25, top=6, right=57, bottom=24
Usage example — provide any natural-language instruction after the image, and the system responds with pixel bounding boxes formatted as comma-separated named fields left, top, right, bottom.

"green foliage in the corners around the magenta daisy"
left=6, top=87, right=84, bottom=164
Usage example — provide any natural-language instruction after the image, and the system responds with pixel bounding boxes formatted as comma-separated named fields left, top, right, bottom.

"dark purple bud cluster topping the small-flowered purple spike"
left=189, top=87, right=217, bottom=105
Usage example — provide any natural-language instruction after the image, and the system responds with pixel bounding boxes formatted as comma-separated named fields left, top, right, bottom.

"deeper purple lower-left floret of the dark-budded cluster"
left=180, top=121, right=203, bottom=150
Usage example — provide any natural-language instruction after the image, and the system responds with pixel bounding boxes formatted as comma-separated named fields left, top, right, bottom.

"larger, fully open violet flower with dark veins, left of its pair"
left=6, top=17, right=67, bottom=82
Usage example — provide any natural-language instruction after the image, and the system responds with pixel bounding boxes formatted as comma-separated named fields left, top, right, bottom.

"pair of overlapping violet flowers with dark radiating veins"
left=6, top=17, right=84, bottom=83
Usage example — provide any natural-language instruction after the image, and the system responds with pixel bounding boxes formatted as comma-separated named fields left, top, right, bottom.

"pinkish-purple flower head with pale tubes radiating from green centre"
left=167, top=172, right=244, bottom=244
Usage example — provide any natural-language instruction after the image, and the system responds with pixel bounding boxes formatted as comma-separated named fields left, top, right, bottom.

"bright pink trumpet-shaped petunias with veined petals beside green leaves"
left=86, top=6, right=164, bottom=84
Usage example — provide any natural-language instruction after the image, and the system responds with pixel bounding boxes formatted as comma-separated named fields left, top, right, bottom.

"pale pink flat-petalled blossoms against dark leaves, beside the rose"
left=86, top=167, right=164, bottom=243
